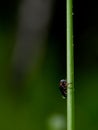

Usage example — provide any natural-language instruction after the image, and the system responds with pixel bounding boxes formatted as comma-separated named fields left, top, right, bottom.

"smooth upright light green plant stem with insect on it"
left=67, top=0, right=74, bottom=130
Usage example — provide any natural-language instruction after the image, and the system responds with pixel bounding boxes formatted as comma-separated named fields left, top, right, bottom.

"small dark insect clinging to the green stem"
left=59, top=79, right=68, bottom=98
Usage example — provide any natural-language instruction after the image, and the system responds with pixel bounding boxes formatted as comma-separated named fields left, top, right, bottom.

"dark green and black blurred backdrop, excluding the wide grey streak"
left=0, top=0, right=98, bottom=130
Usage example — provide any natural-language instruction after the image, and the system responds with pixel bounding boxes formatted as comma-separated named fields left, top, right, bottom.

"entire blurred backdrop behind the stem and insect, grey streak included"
left=0, top=0, right=98, bottom=130
